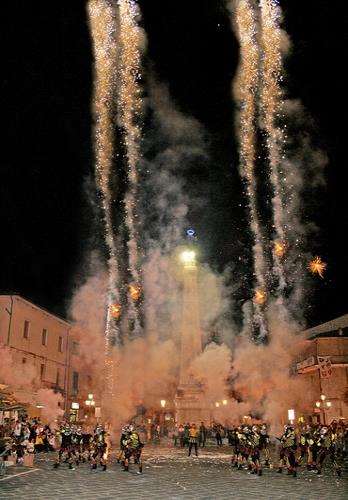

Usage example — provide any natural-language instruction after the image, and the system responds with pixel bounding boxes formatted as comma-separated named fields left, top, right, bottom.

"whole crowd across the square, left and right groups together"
left=0, top=417, right=348, bottom=477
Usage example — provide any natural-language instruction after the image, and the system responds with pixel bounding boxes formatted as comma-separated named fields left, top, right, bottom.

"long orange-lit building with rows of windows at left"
left=0, top=295, right=97, bottom=418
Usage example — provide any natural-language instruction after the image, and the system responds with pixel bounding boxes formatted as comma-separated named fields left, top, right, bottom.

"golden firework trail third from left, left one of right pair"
left=235, top=0, right=267, bottom=338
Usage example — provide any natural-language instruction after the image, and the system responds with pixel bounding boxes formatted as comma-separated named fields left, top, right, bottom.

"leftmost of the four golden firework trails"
left=88, top=0, right=120, bottom=392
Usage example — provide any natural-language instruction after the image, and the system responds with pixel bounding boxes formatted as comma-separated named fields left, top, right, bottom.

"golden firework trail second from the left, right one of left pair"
left=118, top=0, right=142, bottom=334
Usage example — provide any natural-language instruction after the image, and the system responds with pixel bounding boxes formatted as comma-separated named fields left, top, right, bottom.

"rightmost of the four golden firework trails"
left=260, top=0, right=291, bottom=293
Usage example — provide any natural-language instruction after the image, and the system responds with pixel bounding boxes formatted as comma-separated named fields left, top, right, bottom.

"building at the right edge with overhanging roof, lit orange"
left=294, top=314, right=348, bottom=423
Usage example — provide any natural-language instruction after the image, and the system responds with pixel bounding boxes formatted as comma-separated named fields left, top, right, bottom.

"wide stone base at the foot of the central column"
left=174, top=383, right=212, bottom=425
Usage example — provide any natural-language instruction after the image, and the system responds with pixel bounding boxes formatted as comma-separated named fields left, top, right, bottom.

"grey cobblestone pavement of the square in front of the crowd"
left=0, top=447, right=348, bottom=500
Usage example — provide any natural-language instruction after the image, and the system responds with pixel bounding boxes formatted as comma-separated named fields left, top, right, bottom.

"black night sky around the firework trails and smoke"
left=0, top=0, right=348, bottom=325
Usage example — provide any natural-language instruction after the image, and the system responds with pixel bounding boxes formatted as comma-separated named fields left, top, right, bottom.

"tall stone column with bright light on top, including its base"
left=175, top=248, right=210, bottom=423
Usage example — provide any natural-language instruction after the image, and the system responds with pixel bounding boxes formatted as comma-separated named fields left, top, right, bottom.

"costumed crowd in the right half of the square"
left=174, top=421, right=348, bottom=477
